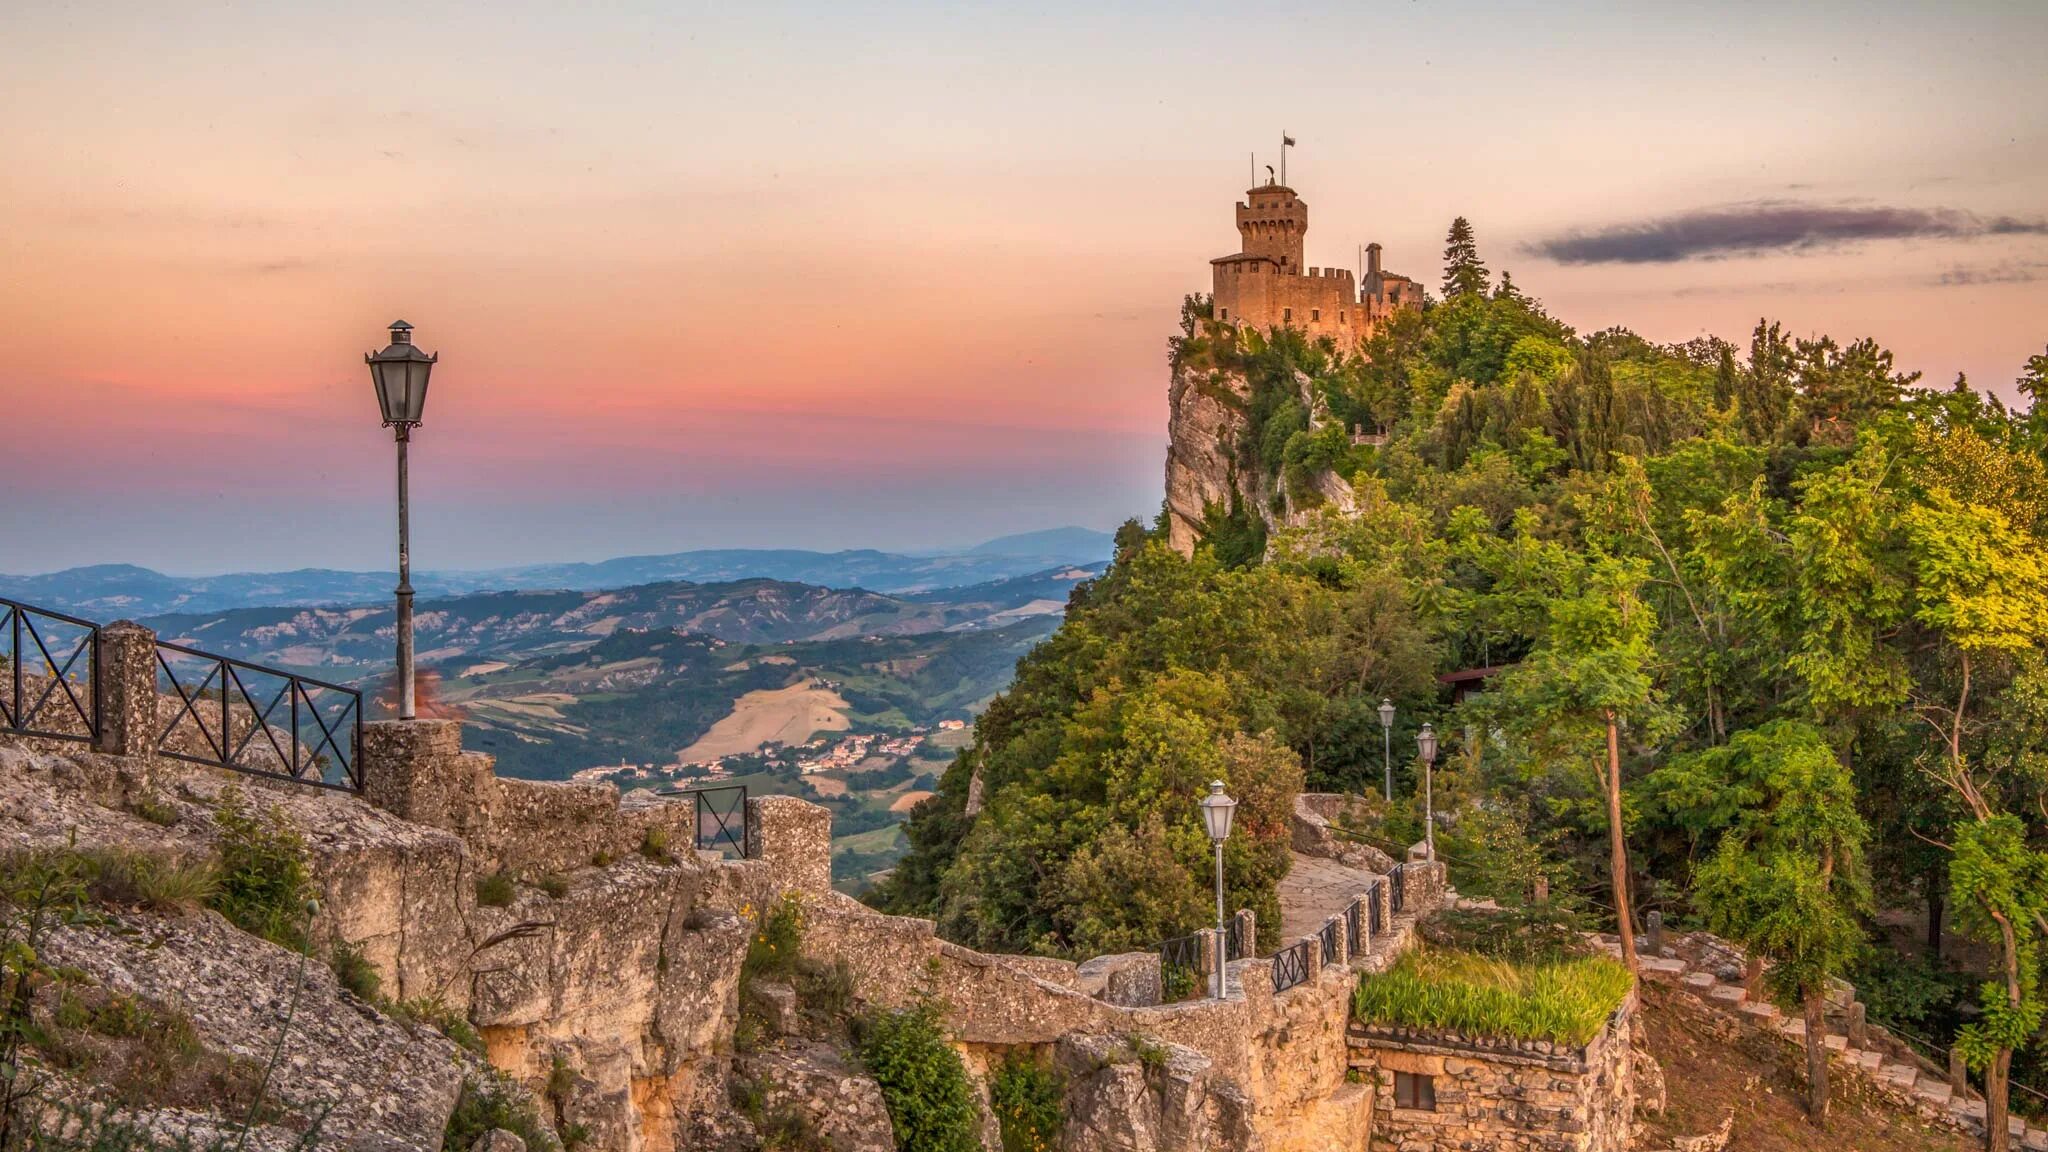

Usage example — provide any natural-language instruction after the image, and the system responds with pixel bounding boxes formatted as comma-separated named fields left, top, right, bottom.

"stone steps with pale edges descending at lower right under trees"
left=1595, top=937, right=2048, bottom=1152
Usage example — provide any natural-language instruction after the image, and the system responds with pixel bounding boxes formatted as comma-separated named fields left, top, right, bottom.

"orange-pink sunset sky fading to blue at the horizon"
left=0, top=0, right=2048, bottom=572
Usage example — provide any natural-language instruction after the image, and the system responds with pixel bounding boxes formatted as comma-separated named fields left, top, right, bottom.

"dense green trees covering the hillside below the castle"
left=877, top=219, right=2048, bottom=1127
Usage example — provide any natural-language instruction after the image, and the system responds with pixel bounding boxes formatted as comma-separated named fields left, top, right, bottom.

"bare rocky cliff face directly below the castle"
left=1165, top=358, right=1354, bottom=556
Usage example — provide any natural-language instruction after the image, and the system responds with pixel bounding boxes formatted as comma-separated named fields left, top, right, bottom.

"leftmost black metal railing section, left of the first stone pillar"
left=0, top=599, right=100, bottom=742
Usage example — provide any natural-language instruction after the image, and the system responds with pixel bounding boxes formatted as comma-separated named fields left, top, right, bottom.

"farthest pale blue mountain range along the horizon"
left=0, top=527, right=1114, bottom=621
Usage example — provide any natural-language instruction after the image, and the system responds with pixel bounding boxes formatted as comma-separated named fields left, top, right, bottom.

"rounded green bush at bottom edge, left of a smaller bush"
left=854, top=1002, right=981, bottom=1152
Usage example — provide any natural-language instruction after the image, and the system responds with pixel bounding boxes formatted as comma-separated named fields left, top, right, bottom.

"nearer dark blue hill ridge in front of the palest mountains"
left=143, top=564, right=1104, bottom=681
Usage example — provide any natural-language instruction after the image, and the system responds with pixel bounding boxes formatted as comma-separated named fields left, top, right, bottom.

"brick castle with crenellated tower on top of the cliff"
left=1208, top=180, right=1421, bottom=351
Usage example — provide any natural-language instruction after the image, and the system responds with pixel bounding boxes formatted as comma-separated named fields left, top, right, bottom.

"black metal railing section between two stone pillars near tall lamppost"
left=156, top=640, right=362, bottom=791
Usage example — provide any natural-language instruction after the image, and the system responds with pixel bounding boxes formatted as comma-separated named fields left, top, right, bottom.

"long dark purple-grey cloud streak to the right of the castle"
left=1528, top=201, right=2048, bottom=264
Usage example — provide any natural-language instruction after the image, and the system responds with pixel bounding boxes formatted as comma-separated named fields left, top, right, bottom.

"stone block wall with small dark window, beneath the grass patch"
left=1350, top=992, right=1636, bottom=1152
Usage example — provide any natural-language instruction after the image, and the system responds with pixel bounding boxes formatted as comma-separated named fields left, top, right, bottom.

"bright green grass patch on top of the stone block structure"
left=1352, top=947, right=1632, bottom=1045
